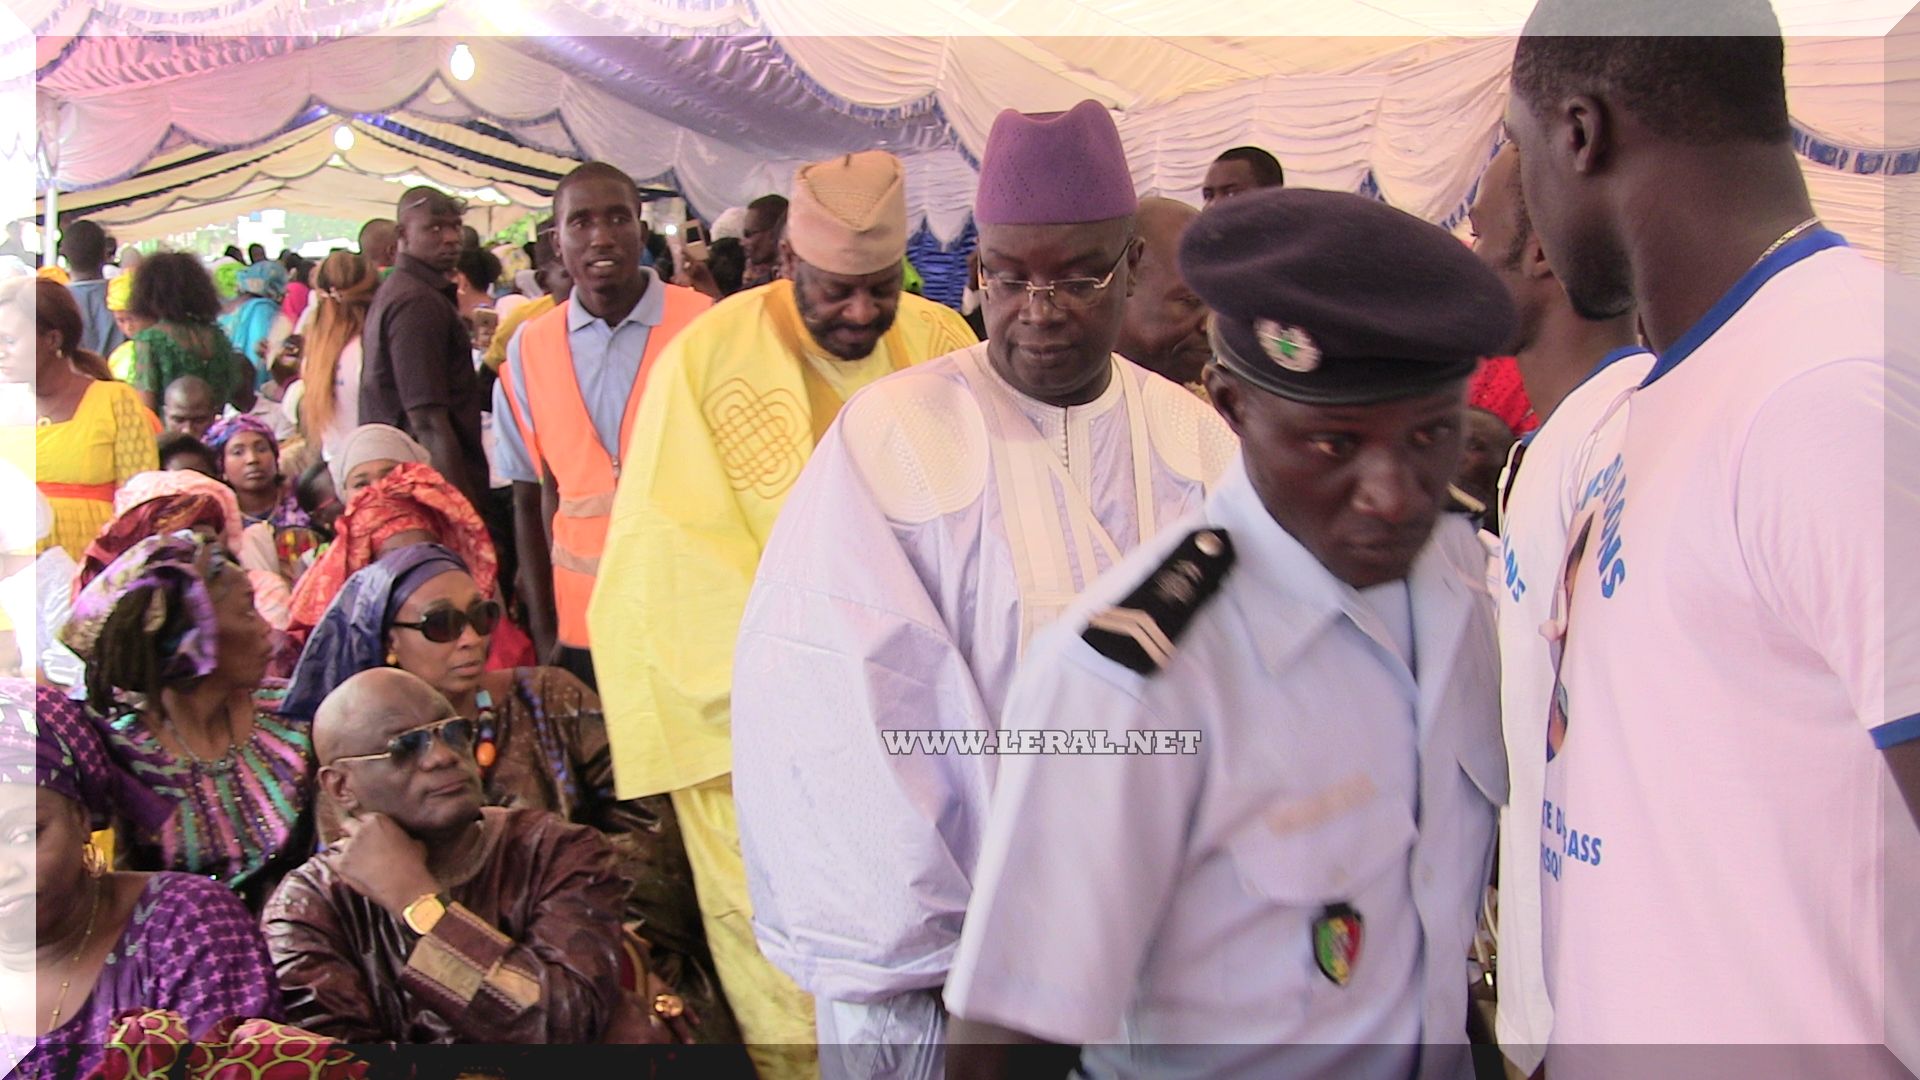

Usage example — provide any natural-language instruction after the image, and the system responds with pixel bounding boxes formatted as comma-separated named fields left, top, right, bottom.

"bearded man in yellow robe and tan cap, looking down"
left=588, top=150, right=973, bottom=1078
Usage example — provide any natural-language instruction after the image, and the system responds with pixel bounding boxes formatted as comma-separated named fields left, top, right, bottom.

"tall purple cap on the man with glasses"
left=973, top=100, right=1140, bottom=225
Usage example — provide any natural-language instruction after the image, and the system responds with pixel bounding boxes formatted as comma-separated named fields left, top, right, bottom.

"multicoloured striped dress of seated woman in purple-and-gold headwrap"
left=40, top=682, right=315, bottom=911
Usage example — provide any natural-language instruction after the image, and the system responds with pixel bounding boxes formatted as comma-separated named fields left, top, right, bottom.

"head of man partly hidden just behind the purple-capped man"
left=1114, top=196, right=1212, bottom=384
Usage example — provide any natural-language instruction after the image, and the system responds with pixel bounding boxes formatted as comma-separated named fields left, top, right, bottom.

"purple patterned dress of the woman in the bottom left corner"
left=13, top=874, right=284, bottom=1080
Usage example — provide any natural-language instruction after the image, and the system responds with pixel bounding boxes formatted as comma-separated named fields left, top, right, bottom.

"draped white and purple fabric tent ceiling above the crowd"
left=15, top=0, right=1920, bottom=263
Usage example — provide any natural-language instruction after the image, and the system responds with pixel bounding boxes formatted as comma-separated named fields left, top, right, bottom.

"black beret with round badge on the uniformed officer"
left=1181, top=188, right=1515, bottom=405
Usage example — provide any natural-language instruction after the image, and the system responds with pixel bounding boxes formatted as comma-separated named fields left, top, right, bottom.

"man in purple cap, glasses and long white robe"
left=732, top=102, right=1235, bottom=1076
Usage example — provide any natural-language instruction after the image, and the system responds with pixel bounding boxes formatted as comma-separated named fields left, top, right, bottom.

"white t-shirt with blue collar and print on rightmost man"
left=1534, top=231, right=1920, bottom=1074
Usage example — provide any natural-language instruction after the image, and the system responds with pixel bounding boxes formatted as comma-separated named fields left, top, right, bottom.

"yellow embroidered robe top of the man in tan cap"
left=588, top=281, right=975, bottom=799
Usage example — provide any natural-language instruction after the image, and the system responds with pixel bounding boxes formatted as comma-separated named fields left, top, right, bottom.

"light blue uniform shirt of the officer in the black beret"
left=947, top=455, right=1507, bottom=1078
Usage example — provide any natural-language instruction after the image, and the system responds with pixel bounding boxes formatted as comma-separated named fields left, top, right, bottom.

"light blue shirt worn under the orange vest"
left=493, top=269, right=666, bottom=484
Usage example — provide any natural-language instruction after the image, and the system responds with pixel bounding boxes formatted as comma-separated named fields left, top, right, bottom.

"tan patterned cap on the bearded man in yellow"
left=787, top=150, right=910, bottom=275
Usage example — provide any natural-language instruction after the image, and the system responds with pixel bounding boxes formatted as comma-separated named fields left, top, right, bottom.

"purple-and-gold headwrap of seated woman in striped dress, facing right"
left=60, top=532, right=240, bottom=680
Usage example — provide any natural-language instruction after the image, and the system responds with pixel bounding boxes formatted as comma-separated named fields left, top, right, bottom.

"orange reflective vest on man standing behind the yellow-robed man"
left=501, top=281, right=712, bottom=650
